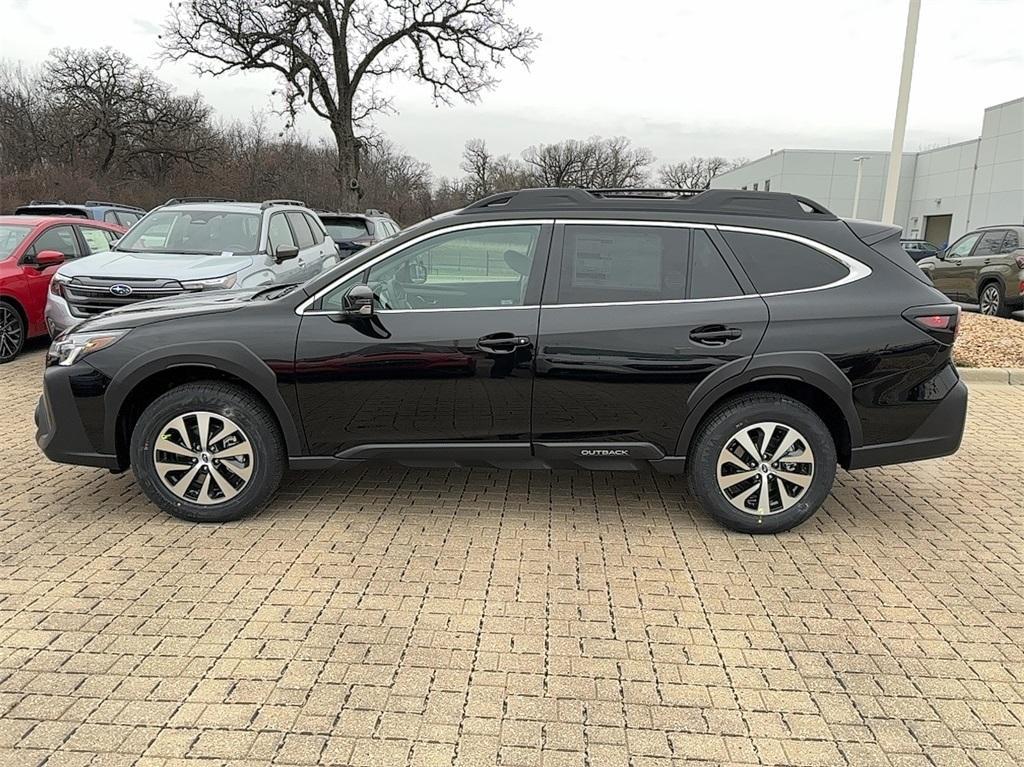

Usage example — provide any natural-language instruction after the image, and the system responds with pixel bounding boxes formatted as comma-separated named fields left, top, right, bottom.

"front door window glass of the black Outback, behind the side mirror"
left=324, top=224, right=541, bottom=311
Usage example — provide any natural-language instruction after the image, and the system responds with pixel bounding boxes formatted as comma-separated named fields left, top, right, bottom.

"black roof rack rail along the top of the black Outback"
left=457, top=188, right=837, bottom=220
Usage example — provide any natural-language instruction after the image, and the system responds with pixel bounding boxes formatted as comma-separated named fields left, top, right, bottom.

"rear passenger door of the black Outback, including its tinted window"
left=534, top=221, right=768, bottom=466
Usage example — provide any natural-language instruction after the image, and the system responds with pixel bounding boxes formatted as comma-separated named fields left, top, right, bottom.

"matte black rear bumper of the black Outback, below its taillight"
left=847, top=381, right=967, bottom=469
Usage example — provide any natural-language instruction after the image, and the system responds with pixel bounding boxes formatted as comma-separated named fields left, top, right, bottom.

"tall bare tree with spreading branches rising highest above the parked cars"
left=162, top=0, right=539, bottom=208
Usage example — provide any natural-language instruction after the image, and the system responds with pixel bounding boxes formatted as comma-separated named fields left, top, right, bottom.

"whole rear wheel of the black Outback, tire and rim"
left=687, top=392, right=836, bottom=535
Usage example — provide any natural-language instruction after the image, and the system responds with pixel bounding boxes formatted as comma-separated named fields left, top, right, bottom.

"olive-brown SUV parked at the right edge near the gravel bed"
left=918, top=224, right=1024, bottom=316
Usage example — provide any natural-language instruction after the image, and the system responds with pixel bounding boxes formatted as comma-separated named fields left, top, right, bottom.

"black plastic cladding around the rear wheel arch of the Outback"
left=676, top=351, right=863, bottom=466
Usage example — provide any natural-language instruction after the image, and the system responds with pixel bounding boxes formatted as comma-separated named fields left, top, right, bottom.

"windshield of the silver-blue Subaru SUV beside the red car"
left=116, top=208, right=260, bottom=256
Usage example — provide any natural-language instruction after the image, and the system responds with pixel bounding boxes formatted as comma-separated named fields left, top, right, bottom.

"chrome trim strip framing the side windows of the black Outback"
left=295, top=218, right=871, bottom=315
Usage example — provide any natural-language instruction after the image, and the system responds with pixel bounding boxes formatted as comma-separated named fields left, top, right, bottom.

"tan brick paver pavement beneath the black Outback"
left=0, top=346, right=1024, bottom=767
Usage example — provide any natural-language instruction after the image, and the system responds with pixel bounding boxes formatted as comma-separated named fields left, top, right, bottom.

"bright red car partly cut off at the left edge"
left=0, top=216, right=127, bottom=363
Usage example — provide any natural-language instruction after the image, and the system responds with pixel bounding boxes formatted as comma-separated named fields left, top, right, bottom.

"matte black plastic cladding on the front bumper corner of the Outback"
left=36, top=363, right=124, bottom=470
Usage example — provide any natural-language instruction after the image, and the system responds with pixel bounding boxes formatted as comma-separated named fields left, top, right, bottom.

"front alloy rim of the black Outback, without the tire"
left=153, top=411, right=255, bottom=506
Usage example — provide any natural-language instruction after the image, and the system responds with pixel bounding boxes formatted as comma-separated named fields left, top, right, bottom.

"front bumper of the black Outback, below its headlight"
left=36, top=363, right=124, bottom=470
